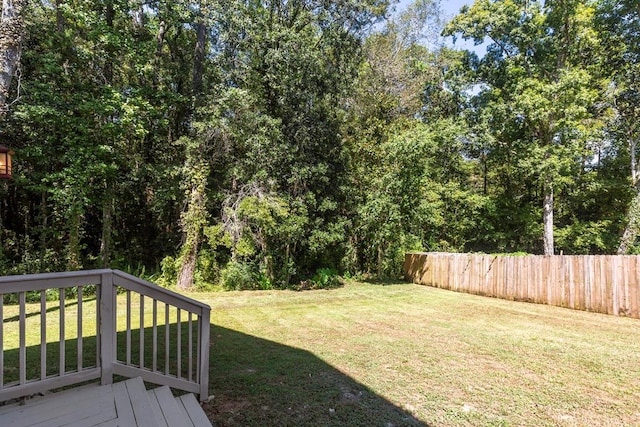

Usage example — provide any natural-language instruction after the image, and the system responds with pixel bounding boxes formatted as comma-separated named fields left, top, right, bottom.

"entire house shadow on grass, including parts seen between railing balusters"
left=4, top=322, right=426, bottom=427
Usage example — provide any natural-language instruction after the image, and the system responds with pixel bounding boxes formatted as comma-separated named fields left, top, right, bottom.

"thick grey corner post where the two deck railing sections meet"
left=98, top=270, right=116, bottom=385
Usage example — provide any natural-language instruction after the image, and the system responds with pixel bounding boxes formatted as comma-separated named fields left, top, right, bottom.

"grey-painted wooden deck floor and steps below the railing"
left=0, top=378, right=211, bottom=427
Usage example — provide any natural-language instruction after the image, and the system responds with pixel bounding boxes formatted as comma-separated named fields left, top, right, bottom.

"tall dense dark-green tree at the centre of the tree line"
left=195, top=0, right=388, bottom=285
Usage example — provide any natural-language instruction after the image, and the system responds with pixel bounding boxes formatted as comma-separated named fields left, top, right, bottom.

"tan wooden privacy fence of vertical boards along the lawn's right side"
left=404, top=253, right=640, bottom=319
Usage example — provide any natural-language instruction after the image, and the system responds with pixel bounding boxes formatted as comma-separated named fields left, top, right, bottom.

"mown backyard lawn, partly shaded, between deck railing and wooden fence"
left=5, top=283, right=640, bottom=426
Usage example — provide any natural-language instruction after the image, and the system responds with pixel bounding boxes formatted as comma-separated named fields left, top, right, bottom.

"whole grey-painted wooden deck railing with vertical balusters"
left=0, top=270, right=210, bottom=402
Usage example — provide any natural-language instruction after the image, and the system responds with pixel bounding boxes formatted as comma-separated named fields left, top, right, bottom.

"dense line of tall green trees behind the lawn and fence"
left=0, top=0, right=640, bottom=288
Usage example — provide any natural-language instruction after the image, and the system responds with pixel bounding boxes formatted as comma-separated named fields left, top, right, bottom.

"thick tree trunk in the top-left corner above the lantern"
left=0, top=0, right=26, bottom=118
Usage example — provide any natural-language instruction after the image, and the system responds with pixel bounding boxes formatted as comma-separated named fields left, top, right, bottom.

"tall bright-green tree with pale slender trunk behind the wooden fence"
left=446, top=0, right=601, bottom=255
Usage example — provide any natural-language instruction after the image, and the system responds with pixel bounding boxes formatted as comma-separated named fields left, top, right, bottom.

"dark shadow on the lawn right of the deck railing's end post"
left=204, top=325, right=426, bottom=427
